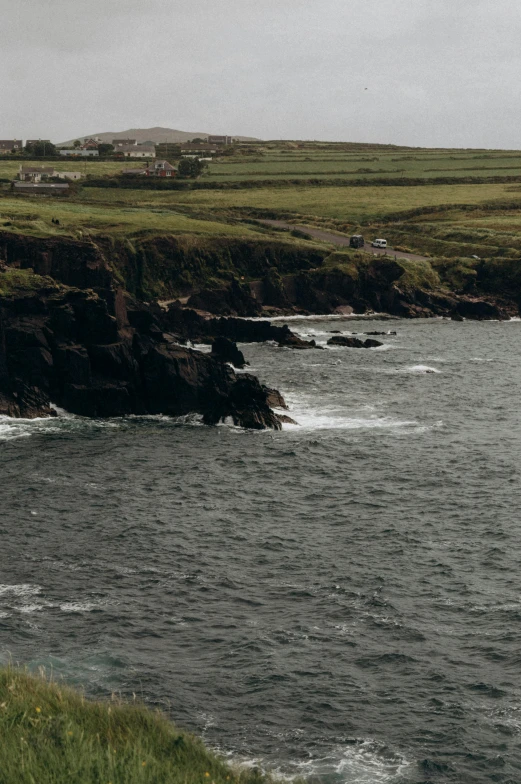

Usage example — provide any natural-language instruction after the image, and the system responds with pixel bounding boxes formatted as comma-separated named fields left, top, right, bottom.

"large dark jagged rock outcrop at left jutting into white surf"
left=0, top=280, right=281, bottom=429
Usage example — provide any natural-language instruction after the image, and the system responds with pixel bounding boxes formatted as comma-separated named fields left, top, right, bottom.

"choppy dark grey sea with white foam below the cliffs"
left=0, top=319, right=521, bottom=784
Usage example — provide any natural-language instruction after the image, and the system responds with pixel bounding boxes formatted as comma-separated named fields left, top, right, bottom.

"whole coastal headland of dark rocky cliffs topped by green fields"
left=0, top=142, right=521, bottom=429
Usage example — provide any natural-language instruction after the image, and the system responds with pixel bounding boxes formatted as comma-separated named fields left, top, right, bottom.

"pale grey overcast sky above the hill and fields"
left=0, top=0, right=521, bottom=149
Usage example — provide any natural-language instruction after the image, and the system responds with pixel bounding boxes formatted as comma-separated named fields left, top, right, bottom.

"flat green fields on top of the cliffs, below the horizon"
left=4, top=142, right=521, bottom=256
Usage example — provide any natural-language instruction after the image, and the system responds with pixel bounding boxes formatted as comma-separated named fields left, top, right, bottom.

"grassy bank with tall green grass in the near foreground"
left=0, top=668, right=269, bottom=784
